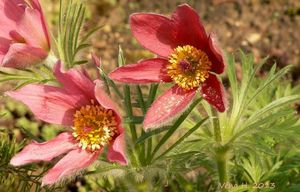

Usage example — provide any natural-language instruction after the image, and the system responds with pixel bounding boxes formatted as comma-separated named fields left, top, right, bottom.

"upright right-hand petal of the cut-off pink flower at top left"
left=17, top=7, right=49, bottom=52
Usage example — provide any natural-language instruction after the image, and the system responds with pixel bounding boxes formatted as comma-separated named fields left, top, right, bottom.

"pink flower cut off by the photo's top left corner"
left=0, top=0, right=50, bottom=68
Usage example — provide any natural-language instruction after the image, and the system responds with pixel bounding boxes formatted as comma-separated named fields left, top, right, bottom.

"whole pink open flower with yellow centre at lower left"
left=6, top=58, right=127, bottom=185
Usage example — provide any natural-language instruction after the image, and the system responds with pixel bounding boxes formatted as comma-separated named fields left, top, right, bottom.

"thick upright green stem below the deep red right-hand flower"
left=213, top=109, right=228, bottom=191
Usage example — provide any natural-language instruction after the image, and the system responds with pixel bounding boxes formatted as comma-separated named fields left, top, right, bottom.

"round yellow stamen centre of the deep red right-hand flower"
left=167, top=45, right=212, bottom=90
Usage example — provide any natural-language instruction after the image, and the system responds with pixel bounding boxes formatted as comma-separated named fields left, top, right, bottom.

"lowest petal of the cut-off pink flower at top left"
left=1, top=43, right=47, bottom=68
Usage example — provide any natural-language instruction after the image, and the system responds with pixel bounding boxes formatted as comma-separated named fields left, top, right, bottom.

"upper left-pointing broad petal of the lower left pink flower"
left=6, top=84, right=88, bottom=126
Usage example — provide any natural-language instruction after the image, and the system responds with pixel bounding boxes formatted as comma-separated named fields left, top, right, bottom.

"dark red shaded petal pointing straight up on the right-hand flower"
left=172, top=4, right=207, bottom=49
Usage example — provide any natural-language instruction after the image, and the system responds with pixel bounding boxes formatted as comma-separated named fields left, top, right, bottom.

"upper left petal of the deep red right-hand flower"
left=130, top=13, right=176, bottom=57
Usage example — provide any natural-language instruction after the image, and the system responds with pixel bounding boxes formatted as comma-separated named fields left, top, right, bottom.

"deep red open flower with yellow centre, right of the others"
left=110, top=4, right=225, bottom=129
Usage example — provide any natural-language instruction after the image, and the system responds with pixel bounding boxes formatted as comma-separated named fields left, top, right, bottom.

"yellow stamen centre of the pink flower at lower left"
left=73, top=100, right=118, bottom=151
